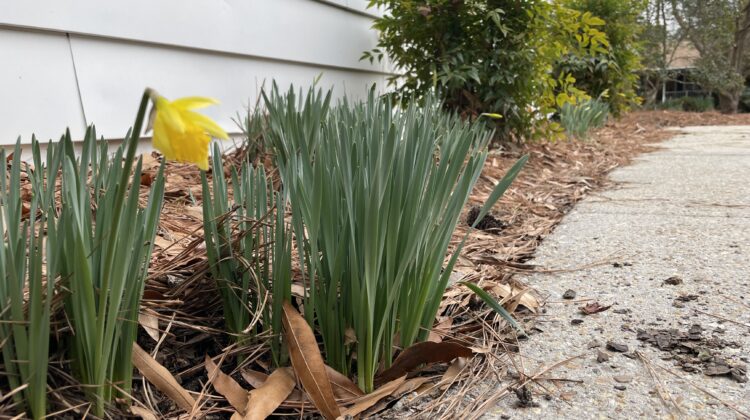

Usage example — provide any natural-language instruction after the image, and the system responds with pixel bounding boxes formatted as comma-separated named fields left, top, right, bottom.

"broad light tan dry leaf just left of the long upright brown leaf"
left=243, top=368, right=296, bottom=420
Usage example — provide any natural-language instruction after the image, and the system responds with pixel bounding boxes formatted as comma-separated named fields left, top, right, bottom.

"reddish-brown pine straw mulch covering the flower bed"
left=0, top=111, right=750, bottom=418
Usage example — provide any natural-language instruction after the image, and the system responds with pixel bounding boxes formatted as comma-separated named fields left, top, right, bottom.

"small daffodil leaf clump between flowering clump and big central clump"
left=202, top=145, right=292, bottom=365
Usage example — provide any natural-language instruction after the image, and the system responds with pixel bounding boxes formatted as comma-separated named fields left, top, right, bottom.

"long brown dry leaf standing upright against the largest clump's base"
left=282, top=302, right=340, bottom=420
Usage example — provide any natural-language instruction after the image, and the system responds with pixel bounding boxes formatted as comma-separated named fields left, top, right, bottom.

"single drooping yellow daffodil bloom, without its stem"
left=152, top=93, right=229, bottom=171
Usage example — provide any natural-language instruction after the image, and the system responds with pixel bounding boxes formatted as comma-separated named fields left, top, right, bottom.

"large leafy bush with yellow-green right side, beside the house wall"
left=363, top=0, right=606, bottom=137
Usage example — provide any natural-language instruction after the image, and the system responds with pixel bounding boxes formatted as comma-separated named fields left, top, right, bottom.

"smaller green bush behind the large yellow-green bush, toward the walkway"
left=557, top=0, right=646, bottom=116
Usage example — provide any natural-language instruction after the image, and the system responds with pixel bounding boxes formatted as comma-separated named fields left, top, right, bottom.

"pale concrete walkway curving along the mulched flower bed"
left=488, top=126, right=750, bottom=419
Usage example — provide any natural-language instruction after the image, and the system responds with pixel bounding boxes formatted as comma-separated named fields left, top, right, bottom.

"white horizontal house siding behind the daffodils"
left=0, top=0, right=389, bottom=144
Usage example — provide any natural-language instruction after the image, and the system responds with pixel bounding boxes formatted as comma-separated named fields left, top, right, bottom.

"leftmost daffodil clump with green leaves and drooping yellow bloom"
left=0, top=89, right=227, bottom=419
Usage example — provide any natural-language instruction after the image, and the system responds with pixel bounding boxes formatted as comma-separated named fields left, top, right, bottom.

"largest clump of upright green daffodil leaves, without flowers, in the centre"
left=264, top=89, right=523, bottom=392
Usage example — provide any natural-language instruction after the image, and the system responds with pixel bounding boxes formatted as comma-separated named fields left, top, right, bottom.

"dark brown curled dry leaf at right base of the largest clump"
left=375, top=341, right=473, bottom=384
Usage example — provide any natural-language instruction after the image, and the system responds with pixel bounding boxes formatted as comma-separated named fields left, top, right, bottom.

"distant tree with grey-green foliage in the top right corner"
left=670, top=0, right=750, bottom=113
